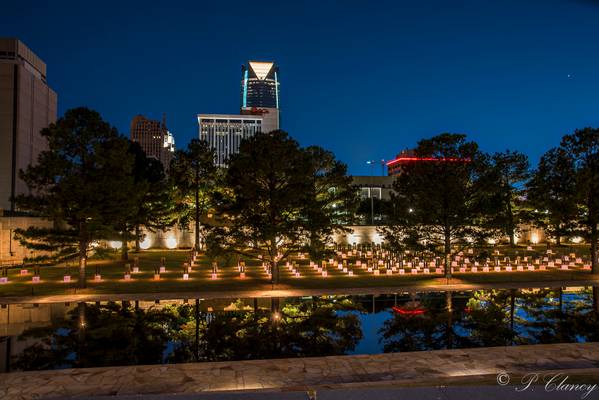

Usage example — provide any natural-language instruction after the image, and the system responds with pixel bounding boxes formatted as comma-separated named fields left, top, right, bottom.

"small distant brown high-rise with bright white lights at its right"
left=130, top=115, right=175, bottom=170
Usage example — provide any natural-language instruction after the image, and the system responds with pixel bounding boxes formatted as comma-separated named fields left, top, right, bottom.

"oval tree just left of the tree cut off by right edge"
left=526, top=148, right=577, bottom=246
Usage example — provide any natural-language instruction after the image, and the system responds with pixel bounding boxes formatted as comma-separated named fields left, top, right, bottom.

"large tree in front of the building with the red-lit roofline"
left=381, top=133, right=491, bottom=277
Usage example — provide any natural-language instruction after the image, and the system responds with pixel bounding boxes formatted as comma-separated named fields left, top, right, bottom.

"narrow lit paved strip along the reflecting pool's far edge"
left=0, top=277, right=599, bottom=304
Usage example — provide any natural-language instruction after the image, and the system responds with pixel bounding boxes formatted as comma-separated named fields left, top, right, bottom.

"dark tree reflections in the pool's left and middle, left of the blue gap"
left=13, top=298, right=362, bottom=370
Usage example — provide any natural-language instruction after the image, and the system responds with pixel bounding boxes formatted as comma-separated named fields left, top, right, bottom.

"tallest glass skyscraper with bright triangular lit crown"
left=241, top=61, right=280, bottom=132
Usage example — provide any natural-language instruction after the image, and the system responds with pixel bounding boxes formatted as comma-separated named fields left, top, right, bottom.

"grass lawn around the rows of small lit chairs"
left=0, top=246, right=592, bottom=297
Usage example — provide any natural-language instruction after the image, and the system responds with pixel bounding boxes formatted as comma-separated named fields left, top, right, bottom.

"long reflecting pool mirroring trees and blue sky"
left=0, top=288, right=599, bottom=372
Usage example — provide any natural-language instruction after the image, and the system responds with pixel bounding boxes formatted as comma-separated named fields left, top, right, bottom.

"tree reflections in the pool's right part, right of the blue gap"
left=379, top=288, right=599, bottom=352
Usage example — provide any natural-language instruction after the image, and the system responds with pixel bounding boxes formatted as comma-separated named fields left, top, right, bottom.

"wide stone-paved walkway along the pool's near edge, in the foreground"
left=0, top=343, right=599, bottom=400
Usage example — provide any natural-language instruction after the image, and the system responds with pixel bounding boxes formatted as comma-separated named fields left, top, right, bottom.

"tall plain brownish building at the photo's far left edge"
left=0, top=38, right=57, bottom=211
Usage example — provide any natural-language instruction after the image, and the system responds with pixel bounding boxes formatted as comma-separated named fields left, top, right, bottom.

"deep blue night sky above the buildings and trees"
left=0, top=0, right=599, bottom=175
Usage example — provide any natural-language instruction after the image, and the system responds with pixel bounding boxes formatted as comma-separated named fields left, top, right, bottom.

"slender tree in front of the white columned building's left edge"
left=169, top=139, right=217, bottom=249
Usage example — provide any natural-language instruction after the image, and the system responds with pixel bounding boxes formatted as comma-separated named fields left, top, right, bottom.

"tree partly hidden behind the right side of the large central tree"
left=305, top=146, right=358, bottom=258
